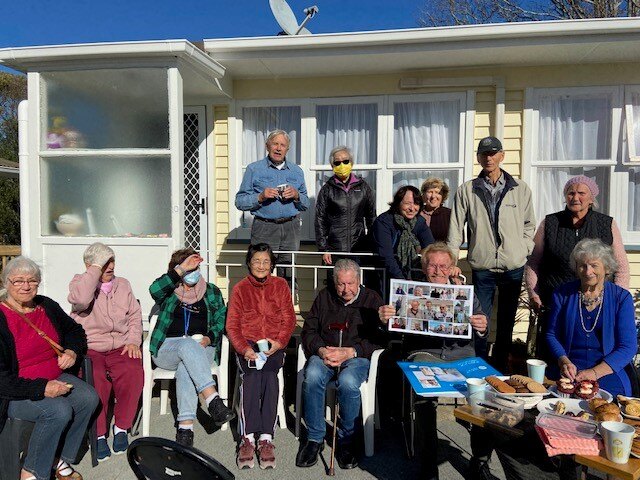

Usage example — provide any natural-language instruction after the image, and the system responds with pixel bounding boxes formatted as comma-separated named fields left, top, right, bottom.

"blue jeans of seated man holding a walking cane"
left=302, top=355, right=369, bottom=443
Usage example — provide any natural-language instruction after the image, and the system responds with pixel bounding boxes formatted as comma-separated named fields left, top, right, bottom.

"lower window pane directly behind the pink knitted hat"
left=535, top=167, right=609, bottom=220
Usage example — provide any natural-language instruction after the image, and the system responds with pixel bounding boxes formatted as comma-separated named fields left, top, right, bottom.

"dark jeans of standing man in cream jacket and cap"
left=471, top=267, right=524, bottom=372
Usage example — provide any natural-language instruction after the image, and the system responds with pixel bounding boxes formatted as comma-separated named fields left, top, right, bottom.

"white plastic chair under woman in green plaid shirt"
left=142, top=315, right=229, bottom=437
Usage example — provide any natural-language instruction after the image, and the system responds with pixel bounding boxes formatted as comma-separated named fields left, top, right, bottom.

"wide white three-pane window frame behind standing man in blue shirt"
left=229, top=90, right=475, bottom=241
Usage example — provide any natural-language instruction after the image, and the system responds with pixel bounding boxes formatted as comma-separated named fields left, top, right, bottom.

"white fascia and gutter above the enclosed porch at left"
left=0, top=40, right=225, bottom=78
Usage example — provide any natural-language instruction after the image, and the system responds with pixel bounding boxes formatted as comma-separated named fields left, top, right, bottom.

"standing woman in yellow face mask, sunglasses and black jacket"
left=315, top=145, right=376, bottom=282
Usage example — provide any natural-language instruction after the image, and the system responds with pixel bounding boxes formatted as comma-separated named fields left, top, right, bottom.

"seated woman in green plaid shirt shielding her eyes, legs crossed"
left=149, top=248, right=235, bottom=446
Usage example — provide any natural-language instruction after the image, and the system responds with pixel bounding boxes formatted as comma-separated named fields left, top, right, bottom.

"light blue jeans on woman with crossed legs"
left=153, top=337, right=216, bottom=422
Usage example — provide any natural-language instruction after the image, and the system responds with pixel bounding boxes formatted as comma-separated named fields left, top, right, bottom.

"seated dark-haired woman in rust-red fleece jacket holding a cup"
left=227, top=243, right=296, bottom=469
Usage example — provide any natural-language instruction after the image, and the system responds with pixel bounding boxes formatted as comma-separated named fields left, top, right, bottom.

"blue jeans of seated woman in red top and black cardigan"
left=7, top=373, right=98, bottom=480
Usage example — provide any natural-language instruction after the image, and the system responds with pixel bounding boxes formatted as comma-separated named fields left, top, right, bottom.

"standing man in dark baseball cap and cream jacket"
left=447, top=137, right=536, bottom=373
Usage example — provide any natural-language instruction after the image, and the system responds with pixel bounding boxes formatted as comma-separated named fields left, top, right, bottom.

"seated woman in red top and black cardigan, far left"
left=0, top=257, right=98, bottom=480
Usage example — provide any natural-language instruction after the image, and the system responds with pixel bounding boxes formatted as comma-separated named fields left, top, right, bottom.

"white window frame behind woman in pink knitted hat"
left=522, top=85, right=640, bottom=245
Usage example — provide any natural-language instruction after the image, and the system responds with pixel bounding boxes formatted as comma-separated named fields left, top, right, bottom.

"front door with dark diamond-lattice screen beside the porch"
left=184, top=107, right=209, bottom=278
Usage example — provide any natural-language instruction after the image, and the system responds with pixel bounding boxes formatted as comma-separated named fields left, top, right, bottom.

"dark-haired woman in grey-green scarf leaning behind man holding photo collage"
left=373, top=185, right=434, bottom=280
